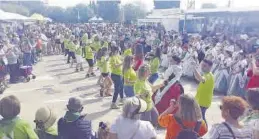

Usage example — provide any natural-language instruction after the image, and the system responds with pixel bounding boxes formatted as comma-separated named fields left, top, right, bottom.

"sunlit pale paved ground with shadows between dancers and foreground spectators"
left=0, top=56, right=222, bottom=138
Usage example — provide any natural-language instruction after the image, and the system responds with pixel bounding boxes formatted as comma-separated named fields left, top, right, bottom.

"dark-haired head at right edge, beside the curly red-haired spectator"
left=247, top=89, right=259, bottom=111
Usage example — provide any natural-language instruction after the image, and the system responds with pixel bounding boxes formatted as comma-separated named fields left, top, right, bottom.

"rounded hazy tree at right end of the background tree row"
left=123, top=4, right=146, bottom=22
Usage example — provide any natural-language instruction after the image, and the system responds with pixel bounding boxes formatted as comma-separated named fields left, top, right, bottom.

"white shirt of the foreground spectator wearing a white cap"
left=110, top=116, right=156, bottom=139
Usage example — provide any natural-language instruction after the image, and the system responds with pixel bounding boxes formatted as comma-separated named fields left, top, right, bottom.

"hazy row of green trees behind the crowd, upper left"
left=0, top=1, right=146, bottom=23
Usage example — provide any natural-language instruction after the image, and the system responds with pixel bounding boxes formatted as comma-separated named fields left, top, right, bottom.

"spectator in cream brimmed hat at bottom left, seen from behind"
left=34, top=107, right=58, bottom=139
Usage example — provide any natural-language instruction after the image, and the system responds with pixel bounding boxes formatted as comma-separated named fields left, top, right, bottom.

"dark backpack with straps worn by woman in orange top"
left=174, top=116, right=201, bottom=139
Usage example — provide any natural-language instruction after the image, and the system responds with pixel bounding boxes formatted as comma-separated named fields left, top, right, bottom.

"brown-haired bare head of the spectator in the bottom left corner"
left=0, top=95, right=21, bottom=119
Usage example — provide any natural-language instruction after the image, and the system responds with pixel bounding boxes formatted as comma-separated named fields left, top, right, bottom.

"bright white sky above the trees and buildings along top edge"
left=48, top=0, right=259, bottom=9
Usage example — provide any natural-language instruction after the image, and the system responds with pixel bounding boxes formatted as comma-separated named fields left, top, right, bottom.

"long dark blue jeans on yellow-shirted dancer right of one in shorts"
left=111, top=73, right=123, bottom=103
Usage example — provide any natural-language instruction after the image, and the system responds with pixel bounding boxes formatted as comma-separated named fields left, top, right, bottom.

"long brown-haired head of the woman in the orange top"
left=178, top=94, right=202, bottom=122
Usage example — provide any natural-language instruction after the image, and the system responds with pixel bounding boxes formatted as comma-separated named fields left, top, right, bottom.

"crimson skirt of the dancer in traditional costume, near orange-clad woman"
left=153, top=83, right=181, bottom=114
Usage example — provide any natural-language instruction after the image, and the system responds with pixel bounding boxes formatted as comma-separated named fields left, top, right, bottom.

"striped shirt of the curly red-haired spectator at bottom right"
left=208, top=123, right=253, bottom=139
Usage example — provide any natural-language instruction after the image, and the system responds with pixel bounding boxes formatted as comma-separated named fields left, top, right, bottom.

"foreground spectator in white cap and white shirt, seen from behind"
left=109, top=97, right=156, bottom=139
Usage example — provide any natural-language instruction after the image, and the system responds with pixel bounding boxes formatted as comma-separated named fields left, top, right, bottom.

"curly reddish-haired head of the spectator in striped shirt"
left=220, top=96, right=248, bottom=120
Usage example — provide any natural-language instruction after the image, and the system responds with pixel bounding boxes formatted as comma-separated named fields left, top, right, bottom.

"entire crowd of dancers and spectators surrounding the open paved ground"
left=0, top=24, right=259, bottom=139
